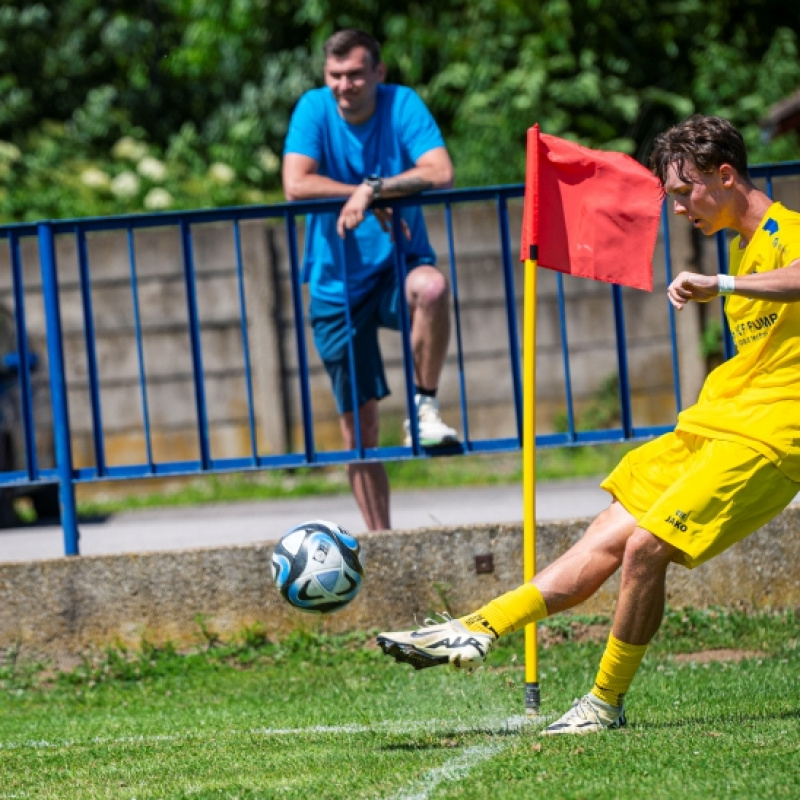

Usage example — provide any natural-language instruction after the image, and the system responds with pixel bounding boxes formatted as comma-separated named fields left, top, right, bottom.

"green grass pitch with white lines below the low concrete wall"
left=0, top=610, right=800, bottom=800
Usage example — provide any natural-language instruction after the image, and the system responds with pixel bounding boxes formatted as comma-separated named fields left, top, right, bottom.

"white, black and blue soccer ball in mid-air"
left=272, top=519, right=364, bottom=614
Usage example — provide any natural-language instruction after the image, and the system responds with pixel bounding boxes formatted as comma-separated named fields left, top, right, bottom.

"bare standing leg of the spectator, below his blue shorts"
left=339, top=398, right=391, bottom=531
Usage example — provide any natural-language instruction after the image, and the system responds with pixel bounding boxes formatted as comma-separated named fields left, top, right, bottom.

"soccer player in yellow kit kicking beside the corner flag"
left=378, top=115, right=800, bottom=735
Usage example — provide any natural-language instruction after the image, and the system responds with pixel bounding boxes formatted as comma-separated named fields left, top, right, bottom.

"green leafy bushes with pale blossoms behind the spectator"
left=0, top=0, right=800, bottom=221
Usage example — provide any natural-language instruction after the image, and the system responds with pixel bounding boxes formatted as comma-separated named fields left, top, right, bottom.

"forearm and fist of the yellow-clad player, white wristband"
left=667, top=259, right=800, bottom=311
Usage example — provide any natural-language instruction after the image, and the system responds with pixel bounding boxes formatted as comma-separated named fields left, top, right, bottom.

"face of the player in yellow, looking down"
left=664, top=164, right=730, bottom=236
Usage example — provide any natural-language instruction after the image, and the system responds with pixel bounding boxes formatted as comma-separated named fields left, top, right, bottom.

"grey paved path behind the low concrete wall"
left=0, top=480, right=608, bottom=563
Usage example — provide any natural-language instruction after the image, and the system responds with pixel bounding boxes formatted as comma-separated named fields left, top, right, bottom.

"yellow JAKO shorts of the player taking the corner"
left=601, top=433, right=800, bottom=569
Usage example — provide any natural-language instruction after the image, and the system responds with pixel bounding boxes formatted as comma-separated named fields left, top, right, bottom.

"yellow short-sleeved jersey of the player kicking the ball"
left=676, top=203, right=800, bottom=482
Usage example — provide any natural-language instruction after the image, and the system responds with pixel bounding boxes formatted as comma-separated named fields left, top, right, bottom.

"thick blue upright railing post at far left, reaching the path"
left=37, top=222, right=80, bottom=556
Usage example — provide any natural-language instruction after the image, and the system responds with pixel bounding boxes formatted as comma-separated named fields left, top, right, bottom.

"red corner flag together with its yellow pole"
left=520, top=125, right=664, bottom=716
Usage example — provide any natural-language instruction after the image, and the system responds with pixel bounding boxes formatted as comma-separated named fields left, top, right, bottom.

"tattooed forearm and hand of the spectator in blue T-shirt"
left=336, top=147, right=454, bottom=237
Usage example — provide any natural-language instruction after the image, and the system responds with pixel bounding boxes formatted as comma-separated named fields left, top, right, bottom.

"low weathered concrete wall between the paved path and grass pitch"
left=0, top=506, right=800, bottom=658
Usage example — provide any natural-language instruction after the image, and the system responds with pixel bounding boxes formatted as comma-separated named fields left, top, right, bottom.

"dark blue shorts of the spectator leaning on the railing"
left=309, top=267, right=401, bottom=414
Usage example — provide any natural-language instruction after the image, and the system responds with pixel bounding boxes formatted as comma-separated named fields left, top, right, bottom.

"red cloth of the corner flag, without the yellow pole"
left=520, top=125, right=664, bottom=292
